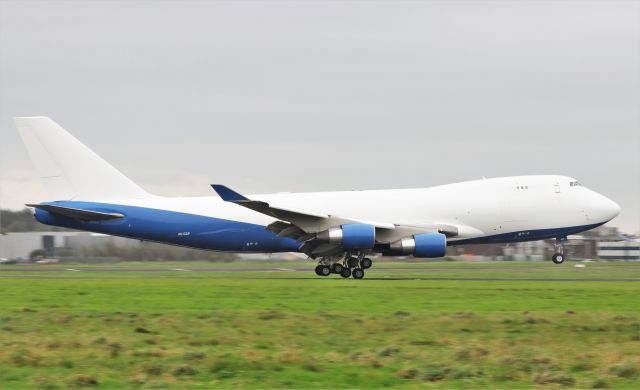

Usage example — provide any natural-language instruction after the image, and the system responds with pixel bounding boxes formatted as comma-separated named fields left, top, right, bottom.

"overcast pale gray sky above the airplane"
left=0, top=1, right=640, bottom=232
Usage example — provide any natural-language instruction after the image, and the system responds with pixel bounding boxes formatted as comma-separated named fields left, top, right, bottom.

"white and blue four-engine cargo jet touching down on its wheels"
left=15, top=117, right=620, bottom=279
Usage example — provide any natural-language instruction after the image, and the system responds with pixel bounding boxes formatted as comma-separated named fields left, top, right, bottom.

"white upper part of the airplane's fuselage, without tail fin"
left=105, top=176, right=620, bottom=243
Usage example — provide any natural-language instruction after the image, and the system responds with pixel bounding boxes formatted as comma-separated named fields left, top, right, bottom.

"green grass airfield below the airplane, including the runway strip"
left=0, top=262, right=640, bottom=389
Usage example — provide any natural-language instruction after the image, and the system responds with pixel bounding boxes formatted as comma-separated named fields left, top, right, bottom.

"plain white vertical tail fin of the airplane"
left=15, top=116, right=150, bottom=200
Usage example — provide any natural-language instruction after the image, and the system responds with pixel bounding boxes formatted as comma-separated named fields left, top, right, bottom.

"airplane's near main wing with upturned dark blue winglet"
left=211, top=184, right=458, bottom=257
